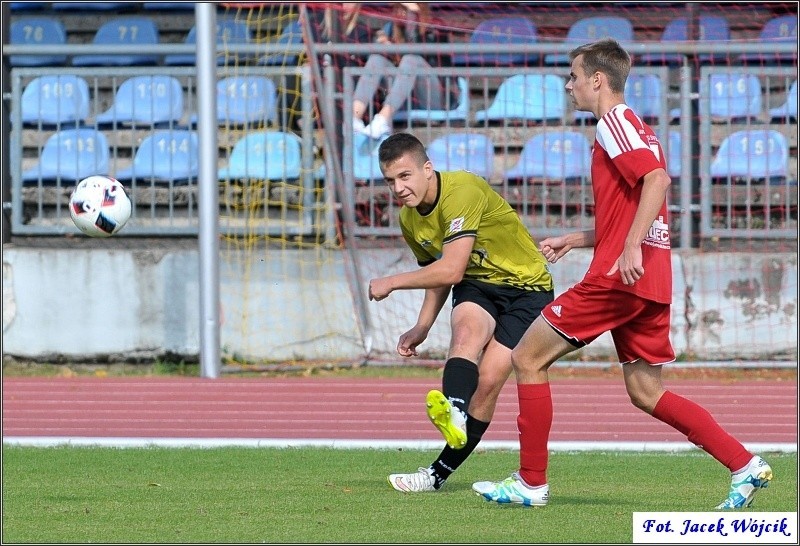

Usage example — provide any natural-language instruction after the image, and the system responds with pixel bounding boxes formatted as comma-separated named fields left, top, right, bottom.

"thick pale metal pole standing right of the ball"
left=194, top=2, right=220, bottom=378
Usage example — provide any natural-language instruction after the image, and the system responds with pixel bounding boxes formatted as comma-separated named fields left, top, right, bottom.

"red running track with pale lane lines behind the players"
left=3, top=377, right=797, bottom=451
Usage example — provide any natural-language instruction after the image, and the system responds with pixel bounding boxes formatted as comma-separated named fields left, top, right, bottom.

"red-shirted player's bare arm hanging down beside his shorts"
left=609, top=168, right=671, bottom=285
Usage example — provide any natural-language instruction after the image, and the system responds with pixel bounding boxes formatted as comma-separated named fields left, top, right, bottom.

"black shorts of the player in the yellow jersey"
left=453, top=280, right=554, bottom=349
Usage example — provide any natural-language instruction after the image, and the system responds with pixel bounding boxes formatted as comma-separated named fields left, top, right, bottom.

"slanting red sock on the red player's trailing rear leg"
left=652, top=391, right=753, bottom=472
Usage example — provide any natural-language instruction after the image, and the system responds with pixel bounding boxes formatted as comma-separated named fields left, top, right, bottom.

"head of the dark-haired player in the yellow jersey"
left=378, top=133, right=436, bottom=208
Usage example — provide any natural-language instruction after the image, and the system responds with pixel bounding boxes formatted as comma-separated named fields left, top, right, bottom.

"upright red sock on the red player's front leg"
left=517, top=383, right=553, bottom=486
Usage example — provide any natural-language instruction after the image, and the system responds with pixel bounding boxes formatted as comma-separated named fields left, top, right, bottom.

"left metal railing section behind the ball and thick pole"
left=9, top=63, right=325, bottom=236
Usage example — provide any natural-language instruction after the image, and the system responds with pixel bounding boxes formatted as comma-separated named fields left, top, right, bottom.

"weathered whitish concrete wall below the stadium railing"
left=3, top=245, right=798, bottom=361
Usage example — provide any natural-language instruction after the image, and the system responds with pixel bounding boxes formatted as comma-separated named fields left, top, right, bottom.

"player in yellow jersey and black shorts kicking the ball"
left=369, top=133, right=553, bottom=493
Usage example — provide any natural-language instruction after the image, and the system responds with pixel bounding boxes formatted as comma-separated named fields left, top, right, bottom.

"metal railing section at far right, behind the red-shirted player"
left=696, top=67, right=798, bottom=239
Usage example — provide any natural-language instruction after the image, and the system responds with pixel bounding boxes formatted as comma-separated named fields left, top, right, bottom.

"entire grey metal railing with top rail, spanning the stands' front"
left=3, top=37, right=797, bottom=242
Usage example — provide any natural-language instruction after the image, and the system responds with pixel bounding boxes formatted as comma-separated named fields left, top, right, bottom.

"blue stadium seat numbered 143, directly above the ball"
left=22, top=127, right=110, bottom=182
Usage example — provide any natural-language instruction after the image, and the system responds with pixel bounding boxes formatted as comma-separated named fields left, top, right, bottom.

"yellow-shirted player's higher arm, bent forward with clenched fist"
left=369, top=235, right=475, bottom=301
